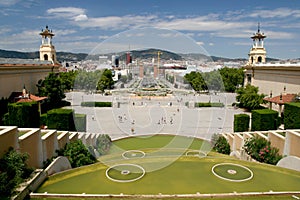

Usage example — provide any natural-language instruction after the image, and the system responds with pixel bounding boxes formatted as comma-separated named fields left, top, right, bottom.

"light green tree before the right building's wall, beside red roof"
left=236, top=85, right=266, bottom=110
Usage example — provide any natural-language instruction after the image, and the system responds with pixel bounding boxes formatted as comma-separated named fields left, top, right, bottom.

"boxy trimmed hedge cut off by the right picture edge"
left=283, top=102, right=300, bottom=129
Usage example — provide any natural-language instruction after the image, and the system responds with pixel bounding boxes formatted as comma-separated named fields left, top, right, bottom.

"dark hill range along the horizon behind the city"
left=0, top=49, right=279, bottom=62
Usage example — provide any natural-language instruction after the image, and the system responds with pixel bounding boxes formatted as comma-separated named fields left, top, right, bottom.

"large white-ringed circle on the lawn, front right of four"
left=211, top=163, right=253, bottom=182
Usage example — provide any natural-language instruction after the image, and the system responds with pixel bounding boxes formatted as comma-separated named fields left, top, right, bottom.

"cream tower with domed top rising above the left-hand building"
left=40, top=26, right=57, bottom=63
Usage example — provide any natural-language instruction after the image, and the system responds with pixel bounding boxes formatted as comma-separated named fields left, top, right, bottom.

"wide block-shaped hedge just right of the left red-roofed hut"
left=47, top=108, right=76, bottom=131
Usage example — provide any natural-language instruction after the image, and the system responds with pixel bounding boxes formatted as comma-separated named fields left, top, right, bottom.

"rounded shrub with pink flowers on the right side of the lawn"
left=244, top=136, right=282, bottom=165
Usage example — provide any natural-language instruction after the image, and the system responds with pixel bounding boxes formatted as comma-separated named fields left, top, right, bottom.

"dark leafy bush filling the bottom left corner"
left=0, top=148, right=33, bottom=199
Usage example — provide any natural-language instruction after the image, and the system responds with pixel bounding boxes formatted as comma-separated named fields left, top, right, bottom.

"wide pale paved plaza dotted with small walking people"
left=66, top=92, right=243, bottom=139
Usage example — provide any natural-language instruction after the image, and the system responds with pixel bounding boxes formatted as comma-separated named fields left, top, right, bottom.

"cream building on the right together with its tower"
left=244, top=24, right=300, bottom=96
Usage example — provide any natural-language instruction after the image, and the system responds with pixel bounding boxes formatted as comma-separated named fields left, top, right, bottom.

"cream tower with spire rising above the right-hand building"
left=248, top=23, right=267, bottom=65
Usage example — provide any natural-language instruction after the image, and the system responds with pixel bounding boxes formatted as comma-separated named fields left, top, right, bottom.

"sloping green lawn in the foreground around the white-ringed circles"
left=37, top=135, right=300, bottom=199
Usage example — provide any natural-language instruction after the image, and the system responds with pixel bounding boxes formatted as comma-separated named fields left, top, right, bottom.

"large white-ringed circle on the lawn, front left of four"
left=106, top=164, right=146, bottom=183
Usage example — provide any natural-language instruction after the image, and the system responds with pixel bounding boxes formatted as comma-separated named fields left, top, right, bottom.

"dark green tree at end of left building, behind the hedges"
left=37, top=73, right=66, bottom=109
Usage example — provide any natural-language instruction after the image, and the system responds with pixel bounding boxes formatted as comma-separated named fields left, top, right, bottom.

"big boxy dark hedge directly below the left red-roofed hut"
left=4, top=102, right=40, bottom=128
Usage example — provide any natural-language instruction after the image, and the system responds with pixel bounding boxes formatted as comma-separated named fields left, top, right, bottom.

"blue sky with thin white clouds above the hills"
left=0, top=0, right=300, bottom=59
